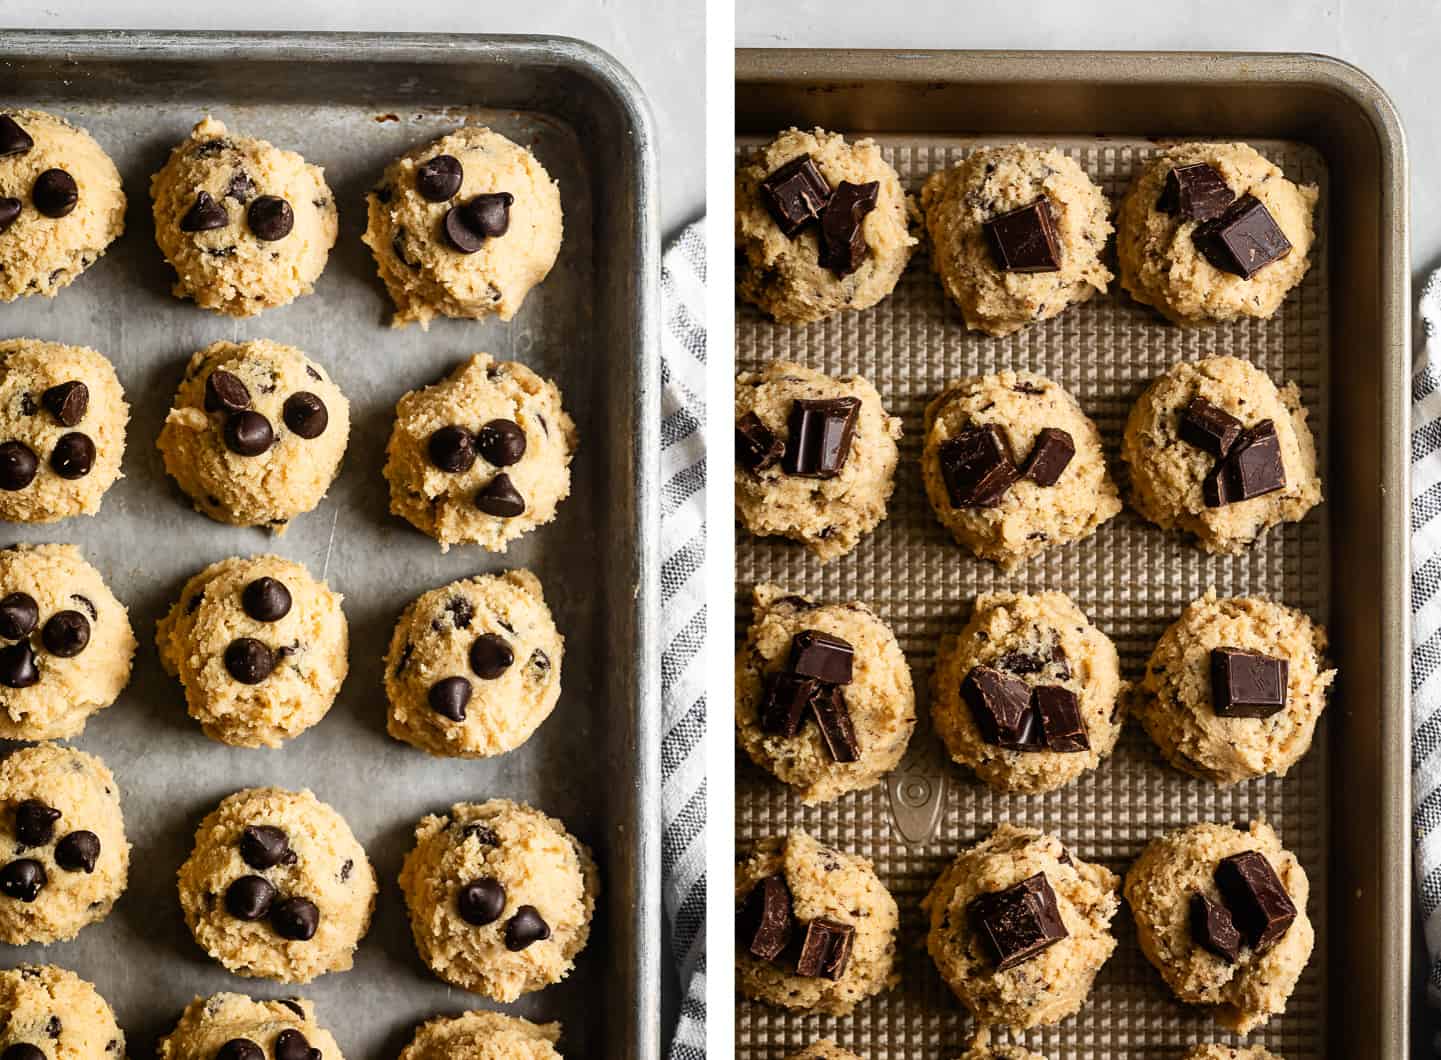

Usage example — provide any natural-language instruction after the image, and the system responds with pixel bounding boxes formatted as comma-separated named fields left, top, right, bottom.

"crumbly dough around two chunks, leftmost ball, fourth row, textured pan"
left=735, top=830, right=901, bottom=1015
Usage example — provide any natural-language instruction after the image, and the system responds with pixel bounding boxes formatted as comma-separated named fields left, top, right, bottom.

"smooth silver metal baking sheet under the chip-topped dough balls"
left=0, top=33, right=660, bottom=1060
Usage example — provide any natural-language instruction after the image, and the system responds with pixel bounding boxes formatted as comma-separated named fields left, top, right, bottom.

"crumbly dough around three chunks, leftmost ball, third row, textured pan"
left=735, top=585, right=915, bottom=802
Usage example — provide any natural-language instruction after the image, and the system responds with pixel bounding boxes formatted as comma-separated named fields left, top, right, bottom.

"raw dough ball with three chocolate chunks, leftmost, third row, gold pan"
left=735, top=585, right=915, bottom=802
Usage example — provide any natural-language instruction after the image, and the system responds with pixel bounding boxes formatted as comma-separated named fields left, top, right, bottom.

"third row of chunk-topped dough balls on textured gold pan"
left=735, top=585, right=1336, bottom=804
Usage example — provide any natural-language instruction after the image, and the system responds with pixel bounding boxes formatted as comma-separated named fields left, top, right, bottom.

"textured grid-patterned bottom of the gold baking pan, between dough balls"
left=736, top=135, right=1330, bottom=1060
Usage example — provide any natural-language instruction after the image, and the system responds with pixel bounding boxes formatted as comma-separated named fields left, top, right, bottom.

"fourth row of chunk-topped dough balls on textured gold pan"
left=735, top=821, right=1316, bottom=1036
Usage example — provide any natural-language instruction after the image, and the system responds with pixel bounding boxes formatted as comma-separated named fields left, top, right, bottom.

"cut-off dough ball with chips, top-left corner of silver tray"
left=0, top=111, right=125, bottom=302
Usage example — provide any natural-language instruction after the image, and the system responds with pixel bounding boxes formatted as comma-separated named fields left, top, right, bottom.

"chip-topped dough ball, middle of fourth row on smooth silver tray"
left=180, top=788, right=376, bottom=982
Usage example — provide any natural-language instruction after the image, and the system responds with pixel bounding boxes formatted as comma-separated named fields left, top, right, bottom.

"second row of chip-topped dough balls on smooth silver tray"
left=0, top=338, right=576, bottom=552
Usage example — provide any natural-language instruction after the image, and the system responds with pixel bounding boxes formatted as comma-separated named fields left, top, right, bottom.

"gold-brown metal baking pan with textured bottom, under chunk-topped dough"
left=736, top=50, right=1409, bottom=1060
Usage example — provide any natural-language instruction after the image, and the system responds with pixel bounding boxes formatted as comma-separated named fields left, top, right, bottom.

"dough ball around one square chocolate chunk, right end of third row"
left=1133, top=590, right=1336, bottom=783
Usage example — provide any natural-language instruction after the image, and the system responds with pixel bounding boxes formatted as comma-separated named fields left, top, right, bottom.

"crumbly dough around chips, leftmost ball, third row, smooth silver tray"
left=0, top=544, right=135, bottom=740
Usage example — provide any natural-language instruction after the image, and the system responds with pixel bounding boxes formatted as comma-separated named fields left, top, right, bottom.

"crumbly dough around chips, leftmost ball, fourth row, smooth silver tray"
left=0, top=743, right=130, bottom=946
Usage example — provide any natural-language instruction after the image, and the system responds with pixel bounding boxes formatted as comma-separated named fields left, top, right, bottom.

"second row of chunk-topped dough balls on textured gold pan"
left=735, top=357, right=1321, bottom=569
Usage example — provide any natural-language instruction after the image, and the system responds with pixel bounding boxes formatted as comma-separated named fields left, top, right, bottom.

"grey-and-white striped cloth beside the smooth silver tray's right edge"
left=660, top=220, right=706, bottom=1060
